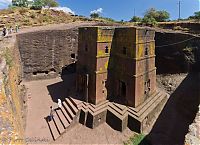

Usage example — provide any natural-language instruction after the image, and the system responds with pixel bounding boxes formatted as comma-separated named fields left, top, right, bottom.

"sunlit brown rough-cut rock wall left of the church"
left=17, top=28, right=78, bottom=80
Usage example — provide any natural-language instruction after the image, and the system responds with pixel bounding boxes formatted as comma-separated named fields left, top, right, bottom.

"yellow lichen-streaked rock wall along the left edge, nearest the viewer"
left=0, top=37, right=25, bottom=144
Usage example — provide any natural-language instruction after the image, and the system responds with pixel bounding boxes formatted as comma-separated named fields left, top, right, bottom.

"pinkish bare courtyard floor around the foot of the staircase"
left=24, top=75, right=133, bottom=144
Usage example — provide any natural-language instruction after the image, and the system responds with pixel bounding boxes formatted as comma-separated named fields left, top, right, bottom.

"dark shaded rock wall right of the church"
left=155, top=32, right=200, bottom=74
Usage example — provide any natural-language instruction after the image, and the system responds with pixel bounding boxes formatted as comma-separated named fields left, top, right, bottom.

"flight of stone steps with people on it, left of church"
left=48, top=98, right=78, bottom=140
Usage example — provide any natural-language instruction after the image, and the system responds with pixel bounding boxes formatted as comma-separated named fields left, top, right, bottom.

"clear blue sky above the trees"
left=0, top=0, right=200, bottom=20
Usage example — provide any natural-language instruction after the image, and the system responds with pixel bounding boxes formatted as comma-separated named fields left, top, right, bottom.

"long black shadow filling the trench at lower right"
left=140, top=72, right=200, bottom=145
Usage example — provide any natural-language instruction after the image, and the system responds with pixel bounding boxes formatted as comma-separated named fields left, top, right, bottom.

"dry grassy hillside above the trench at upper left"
left=0, top=8, right=97, bottom=28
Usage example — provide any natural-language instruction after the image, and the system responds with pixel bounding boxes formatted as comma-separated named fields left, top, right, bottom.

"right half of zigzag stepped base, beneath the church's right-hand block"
left=106, top=90, right=168, bottom=133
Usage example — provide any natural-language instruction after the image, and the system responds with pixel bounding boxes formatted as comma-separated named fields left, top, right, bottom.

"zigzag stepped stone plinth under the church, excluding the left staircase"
left=68, top=91, right=169, bottom=133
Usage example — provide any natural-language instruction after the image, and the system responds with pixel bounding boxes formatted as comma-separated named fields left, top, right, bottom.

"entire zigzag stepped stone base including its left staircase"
left=48, top=91, right=168, bottom=140
